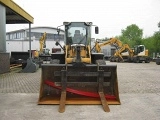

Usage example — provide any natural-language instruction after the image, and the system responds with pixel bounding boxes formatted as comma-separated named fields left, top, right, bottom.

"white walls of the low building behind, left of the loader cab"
left=6, top=27, right=64, bottom=52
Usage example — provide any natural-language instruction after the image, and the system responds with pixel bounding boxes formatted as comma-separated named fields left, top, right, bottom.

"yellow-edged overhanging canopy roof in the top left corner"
left=0, top=0, right=34, bottom=24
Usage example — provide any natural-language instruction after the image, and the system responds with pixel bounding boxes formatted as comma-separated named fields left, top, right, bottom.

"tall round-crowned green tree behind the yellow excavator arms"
left=120, top=24, right=143, bottom=47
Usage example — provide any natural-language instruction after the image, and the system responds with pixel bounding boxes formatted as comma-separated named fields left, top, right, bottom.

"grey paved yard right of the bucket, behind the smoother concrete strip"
left=113, top=62, right=160, bottom=94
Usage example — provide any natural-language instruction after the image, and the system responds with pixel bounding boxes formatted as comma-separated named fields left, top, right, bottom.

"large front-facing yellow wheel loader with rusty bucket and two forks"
left=38, top=22, right=120, bottom=112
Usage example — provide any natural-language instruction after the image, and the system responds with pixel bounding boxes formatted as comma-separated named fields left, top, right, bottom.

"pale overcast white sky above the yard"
left=6, top=0, right=160, bottom=38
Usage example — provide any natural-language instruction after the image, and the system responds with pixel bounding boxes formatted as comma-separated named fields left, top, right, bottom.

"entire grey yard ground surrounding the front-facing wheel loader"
left=0, top=62, right=160, bottom=120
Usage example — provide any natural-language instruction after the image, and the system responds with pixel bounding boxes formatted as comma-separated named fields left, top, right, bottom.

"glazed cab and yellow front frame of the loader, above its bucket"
left=64, top=22, right=92, bottom=65
